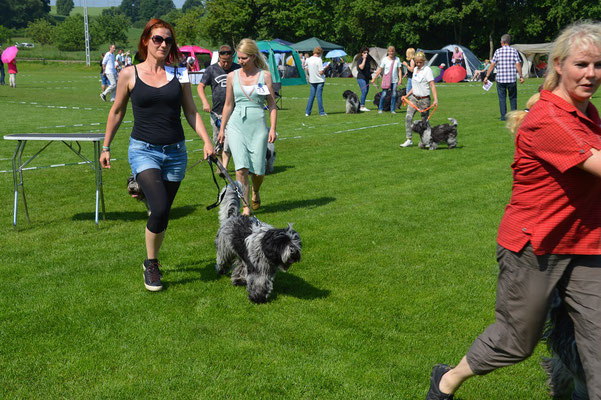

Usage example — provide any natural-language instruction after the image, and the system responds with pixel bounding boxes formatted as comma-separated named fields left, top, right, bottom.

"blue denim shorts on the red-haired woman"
left=128, top=137, right=188, bottom=182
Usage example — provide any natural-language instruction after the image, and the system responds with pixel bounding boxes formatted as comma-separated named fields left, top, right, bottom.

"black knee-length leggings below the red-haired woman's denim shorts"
left=136, top=168, right=181, bottom=233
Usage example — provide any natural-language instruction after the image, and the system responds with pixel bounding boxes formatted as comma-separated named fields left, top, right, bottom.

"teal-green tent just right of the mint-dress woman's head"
left=257, top=40, right=307, bottom=86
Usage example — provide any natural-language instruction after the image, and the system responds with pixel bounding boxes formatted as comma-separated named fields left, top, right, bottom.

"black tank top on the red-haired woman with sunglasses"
left=130, top=65, right=184, bottom=145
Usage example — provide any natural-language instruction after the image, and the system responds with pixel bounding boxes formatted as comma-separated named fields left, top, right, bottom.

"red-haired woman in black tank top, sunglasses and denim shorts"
left=100, top=19, right=215, bottom=291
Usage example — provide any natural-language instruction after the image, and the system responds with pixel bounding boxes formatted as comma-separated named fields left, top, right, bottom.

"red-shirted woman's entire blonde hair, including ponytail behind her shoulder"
left=505, top=21, right=601, bottom=136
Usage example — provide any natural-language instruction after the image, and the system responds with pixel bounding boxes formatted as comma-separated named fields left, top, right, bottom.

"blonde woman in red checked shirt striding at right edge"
left=426, top=23, right=601, bottom=400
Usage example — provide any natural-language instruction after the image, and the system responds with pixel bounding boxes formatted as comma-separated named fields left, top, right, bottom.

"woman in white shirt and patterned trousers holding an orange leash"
left=401, top=51, right=438, bottom=147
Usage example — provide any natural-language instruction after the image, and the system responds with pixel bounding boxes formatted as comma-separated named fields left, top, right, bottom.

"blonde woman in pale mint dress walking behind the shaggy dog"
left=218, top=39, right=277, bottom=215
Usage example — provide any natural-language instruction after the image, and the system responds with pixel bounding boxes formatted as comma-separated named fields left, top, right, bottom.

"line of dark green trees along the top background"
left=0, top=0, right=601, bottom=58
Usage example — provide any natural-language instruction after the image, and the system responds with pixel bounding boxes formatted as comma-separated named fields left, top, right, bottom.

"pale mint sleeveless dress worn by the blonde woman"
left=227, top=70, right=269, bottom=175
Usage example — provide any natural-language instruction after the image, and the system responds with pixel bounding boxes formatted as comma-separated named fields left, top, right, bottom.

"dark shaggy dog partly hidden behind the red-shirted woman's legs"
left=541, top=290, right=589, bottom=400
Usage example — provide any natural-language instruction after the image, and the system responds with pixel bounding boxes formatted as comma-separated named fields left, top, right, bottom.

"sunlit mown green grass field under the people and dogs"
left=0, top=63, right=599, bottom=400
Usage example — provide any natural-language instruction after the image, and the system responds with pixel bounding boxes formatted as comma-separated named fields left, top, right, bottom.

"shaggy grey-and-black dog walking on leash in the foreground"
left=215, top=182, right=301, bottom=303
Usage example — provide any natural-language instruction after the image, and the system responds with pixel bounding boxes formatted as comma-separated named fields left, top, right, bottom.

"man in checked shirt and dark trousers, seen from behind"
left=483, top=34, right=524, bottom=121
